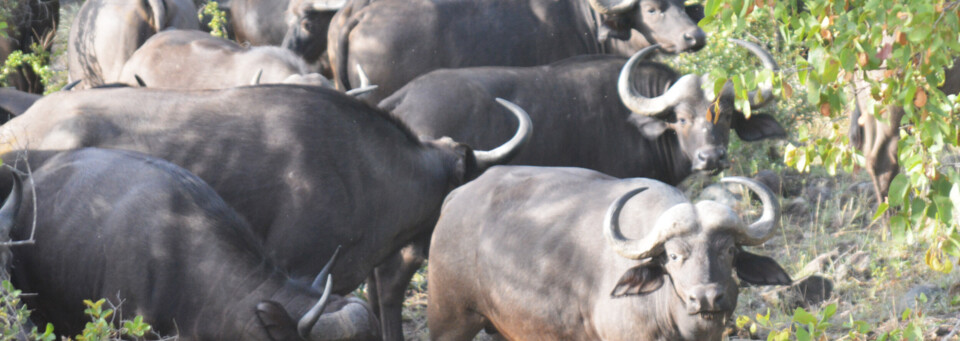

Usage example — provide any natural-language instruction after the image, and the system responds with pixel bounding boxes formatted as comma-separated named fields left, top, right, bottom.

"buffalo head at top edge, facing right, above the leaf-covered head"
left=589, top=0, right=707, bottom=52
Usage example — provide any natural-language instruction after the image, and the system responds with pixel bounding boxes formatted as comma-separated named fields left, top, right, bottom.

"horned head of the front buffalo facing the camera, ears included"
left=603, top=177, right=791, bottom=330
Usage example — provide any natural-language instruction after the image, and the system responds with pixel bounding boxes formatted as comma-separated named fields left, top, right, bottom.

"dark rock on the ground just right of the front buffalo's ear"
left=760, top=275, right=833, bottom=313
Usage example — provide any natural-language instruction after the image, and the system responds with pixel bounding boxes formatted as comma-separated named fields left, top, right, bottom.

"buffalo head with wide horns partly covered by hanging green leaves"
left=617, top=40, right=786, bottom=172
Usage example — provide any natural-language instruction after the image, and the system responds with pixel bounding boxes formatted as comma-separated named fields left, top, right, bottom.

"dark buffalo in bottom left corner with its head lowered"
left=0, top=149, right=379, bottom=340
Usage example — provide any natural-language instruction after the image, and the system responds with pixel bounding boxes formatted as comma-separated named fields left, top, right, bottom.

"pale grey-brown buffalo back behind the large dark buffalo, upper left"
left=118, top=30, right=333, bottom=89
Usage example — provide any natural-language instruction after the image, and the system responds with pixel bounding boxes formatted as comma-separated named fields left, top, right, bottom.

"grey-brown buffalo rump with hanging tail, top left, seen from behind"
left=67, top=0, right=200, bottom=88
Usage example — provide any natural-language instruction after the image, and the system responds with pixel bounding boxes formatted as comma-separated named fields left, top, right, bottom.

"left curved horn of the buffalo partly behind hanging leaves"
left=617, top=44, right=702, bottom=116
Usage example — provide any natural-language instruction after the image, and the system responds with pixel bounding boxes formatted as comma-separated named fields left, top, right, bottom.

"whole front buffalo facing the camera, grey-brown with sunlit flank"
left=427, top=167, right=791, bottom=340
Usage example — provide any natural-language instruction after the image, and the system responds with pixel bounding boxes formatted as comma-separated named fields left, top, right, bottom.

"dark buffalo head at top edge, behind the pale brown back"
left=282, top=0, right=346, bottom=63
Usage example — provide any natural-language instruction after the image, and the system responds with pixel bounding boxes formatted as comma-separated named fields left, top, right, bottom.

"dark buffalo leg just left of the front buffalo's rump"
left=368, top=233, right=430, bottom=341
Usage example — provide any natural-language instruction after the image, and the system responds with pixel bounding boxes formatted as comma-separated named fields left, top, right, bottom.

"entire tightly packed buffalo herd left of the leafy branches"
left=0, top=0, right=791, bottom=340
